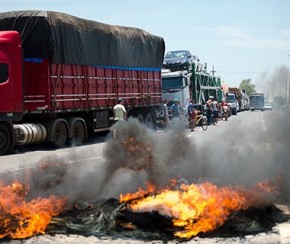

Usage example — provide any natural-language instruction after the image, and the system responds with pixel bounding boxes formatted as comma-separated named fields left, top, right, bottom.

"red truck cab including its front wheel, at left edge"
left=0, top=31, right=24, bottom=154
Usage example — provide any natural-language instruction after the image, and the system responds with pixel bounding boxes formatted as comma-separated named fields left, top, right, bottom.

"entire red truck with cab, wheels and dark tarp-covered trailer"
left=0, top=10, right=165, bottom=154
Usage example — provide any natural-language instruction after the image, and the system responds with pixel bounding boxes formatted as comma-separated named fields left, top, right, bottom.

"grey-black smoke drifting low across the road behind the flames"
left=6, top=111, right=290, bottom=207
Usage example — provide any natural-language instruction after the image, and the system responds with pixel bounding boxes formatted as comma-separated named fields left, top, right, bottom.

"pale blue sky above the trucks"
left=0, top=0, right=290, bottom=86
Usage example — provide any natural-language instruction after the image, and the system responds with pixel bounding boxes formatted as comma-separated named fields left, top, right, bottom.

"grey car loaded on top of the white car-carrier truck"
left=163, top=50, right=201, bottom=72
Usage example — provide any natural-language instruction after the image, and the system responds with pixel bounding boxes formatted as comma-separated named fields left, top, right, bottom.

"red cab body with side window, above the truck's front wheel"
left=0, top=31, right=24, bottom=113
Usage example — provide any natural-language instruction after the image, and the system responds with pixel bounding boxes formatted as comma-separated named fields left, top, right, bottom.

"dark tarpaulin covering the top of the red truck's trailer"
left=0, top=10, right=165, bottom=68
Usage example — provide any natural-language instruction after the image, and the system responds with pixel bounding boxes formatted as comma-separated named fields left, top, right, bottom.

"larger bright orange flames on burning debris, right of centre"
left=120, top=181, right=278, bottom=238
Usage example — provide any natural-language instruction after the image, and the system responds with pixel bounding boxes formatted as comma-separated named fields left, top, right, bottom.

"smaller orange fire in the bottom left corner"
left=0, top=181, right=66, bottom=239
